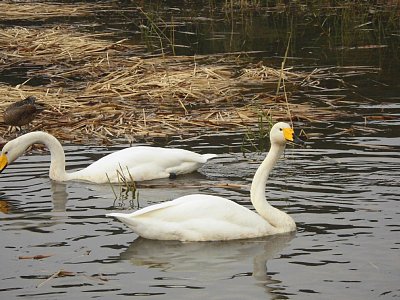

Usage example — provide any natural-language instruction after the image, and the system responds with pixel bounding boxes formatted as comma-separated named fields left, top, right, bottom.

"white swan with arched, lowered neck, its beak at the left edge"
left=0, top=131, right=216, bottom=183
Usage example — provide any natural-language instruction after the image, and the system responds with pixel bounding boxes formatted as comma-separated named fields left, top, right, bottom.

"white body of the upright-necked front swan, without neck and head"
left=107, top=194, right=274, bottom=241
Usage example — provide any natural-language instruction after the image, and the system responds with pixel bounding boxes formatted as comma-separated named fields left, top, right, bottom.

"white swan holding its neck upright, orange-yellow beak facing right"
left=106, top=122, right=303, bottom=241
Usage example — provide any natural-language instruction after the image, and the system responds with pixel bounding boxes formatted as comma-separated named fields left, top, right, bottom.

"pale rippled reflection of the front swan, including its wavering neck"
left=120, top=234, right=295, bottom=299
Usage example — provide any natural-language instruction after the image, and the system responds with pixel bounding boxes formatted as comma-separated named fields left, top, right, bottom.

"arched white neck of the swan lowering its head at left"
left=22, top=132, right=69, bottom=181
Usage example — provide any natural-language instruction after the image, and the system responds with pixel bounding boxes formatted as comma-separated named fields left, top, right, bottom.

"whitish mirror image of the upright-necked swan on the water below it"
left=120, top=233, right=295, bottom=282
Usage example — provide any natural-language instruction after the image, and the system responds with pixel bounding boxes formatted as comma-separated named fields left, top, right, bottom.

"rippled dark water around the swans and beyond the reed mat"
left=0, top=1, right=400, bottom=300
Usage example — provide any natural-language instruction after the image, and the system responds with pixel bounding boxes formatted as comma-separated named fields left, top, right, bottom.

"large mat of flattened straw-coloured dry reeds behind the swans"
left=0, top=27, right=376, bottom=143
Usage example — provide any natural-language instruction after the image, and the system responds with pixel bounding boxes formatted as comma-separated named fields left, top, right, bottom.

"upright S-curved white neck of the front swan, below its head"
left=250, top=144, right=296, bottom=232
